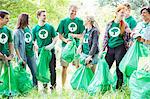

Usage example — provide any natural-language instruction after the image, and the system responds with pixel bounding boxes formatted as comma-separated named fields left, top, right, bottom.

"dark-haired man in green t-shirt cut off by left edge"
left=0, top=10, right=14, bottom=75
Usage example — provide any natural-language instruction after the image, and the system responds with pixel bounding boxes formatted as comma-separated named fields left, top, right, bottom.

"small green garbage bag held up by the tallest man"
left=61, top=35, right=78, bottom=63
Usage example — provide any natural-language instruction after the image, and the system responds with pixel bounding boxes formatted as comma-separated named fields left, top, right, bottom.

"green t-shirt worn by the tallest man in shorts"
left=57, top=17, right=85, bottom=47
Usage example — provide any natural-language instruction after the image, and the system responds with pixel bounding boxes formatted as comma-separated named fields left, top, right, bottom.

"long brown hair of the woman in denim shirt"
left=17, top=13, right=29, bottom=29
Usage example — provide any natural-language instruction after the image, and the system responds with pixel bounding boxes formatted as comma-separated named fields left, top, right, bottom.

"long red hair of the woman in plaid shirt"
left=116, top=5, right=126, bottom=35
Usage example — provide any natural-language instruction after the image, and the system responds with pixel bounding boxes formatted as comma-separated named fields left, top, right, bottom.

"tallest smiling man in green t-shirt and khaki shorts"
left=57, top=5, right=85, bottom=87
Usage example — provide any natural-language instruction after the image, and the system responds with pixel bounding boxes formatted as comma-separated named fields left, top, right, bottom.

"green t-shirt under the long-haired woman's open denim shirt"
left=24, top=27, right=34, bottom=57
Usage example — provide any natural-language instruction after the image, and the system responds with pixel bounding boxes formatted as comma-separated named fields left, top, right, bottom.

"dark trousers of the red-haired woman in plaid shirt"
left=105, top=44, right=126, bottom=89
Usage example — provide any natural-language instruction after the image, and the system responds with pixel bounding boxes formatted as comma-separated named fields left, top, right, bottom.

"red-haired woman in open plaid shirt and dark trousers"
left=103, top=5, right=131, bottom=89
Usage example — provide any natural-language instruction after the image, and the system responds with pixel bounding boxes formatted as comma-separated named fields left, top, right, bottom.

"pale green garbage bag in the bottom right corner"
left=129, top=70, right=150, bottom=99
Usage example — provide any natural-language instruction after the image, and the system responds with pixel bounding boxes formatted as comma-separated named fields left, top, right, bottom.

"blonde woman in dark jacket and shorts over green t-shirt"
left=77, top=16, right=99, bottom=72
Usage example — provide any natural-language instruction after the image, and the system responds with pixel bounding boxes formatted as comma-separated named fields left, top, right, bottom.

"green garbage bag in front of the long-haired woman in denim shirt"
left=14, top=64, right=33, bottom=94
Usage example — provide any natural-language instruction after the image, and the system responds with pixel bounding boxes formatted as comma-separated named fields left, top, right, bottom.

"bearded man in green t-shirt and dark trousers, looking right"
left=32, top=10, right=57, bottom=90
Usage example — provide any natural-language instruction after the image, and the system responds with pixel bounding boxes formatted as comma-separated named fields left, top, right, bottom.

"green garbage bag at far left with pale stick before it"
left=0, top=62, right=19, bottom=96
